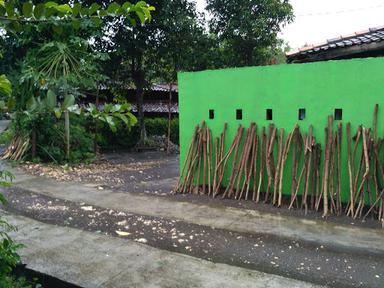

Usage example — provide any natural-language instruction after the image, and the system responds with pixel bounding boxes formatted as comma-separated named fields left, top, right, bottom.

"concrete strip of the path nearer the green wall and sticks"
left=9, top=165, right=384, bottom=255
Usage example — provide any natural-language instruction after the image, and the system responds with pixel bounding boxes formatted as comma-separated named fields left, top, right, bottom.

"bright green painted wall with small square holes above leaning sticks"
left=179, top=58, right=384, bottom=200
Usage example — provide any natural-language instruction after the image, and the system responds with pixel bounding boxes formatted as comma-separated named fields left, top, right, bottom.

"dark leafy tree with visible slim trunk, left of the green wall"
left=100, top=0, right=208, bottom=145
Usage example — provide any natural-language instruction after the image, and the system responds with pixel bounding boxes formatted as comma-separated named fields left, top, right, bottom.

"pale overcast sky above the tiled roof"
left=196, top=0, right=384, bottom=48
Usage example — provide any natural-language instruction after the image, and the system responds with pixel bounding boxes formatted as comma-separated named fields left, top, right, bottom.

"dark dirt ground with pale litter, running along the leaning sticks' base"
left=21, top=152, right=382, bottom=229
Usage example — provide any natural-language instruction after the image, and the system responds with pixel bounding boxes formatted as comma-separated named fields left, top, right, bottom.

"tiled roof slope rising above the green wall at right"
left=286, top=26, right=384, bottom=60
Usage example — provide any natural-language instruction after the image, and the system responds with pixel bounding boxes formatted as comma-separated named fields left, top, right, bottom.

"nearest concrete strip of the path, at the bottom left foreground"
left=0, top=210, right=320, bottom=288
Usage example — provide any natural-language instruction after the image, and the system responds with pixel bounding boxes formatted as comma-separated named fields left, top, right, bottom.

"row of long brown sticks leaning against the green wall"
left=175, top=105, right=384, bottom=221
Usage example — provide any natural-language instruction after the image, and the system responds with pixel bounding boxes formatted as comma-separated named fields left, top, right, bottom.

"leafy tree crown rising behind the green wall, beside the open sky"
left=207, top=0, right=293, bottom=67
